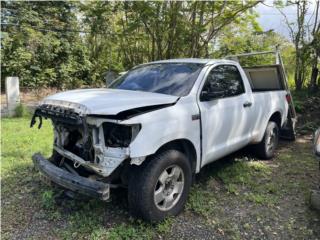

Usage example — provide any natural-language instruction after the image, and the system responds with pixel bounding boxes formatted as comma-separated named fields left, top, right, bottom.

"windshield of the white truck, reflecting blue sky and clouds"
left=109, top=63, right=203, bottom=96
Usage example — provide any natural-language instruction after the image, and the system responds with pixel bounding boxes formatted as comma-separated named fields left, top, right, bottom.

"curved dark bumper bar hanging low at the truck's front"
left=32, top=153, right=110, bottom=201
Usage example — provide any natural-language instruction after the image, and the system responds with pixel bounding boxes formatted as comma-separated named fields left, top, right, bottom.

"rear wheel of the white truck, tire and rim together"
left=255, top=121, right=279, bottom=160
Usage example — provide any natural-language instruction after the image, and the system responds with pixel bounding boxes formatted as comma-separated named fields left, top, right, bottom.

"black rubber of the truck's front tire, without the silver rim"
left=128, top=150, right=192, bottom=222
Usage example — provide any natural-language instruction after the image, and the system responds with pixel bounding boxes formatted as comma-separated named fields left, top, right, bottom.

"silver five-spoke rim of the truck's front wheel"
left=154, top=165, right=184, bottom=211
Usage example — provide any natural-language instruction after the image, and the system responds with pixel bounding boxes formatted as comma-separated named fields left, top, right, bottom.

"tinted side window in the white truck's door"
left=202, top=65, right=244, bottom=98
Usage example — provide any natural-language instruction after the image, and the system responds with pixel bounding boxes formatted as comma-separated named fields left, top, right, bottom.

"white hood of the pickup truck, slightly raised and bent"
left=42, top=88, right=178, bottom=115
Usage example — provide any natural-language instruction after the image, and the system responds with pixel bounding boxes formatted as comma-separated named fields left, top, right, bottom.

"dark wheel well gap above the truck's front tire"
left=156, top=139, right=197, bottom=173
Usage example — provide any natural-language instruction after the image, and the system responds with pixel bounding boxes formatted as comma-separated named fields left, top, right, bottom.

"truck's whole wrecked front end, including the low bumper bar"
left=31, top=104, right=141, bottom=200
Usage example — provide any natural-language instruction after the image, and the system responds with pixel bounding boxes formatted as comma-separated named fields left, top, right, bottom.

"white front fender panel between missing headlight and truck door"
left=122, top=96, right=200, bottom=171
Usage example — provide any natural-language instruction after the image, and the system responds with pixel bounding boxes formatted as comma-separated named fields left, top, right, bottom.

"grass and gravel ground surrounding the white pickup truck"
left=1, top=93, right=320, bottom=239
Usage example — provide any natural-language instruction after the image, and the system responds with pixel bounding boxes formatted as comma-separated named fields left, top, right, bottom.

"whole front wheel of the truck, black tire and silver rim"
left=128, top=150, right=192, bottom=222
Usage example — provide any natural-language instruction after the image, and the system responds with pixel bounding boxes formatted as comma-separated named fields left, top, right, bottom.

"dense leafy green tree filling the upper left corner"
left=1, top=1, right=90, bottom=88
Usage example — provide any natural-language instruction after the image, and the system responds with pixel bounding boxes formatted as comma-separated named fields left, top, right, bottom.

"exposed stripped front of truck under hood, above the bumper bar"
left=31, top=104, right=141, bottom=177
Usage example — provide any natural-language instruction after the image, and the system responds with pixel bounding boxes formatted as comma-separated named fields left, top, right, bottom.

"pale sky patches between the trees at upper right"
left=255, top=0, right=315, bottom=38
